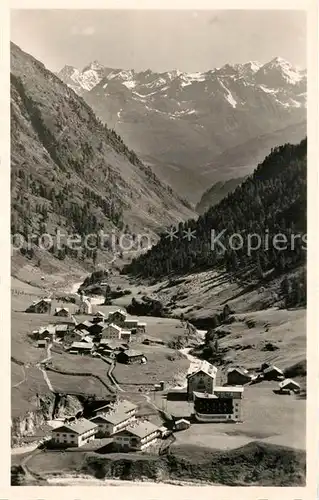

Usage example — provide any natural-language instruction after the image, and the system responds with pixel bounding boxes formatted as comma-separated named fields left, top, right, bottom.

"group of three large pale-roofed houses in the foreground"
left=52, top=400, right=167, bottom=451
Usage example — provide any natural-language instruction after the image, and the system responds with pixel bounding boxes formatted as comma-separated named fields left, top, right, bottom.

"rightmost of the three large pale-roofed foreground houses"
left=113, top=420, right=161, bottom=451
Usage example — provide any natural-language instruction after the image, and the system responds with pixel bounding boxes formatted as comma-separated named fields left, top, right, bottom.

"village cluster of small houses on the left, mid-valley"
left=32, top=307, right=147, bottom=364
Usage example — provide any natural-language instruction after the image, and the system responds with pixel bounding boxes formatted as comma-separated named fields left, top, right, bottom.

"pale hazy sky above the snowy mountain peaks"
left=11, top=10, right=306, bottom=72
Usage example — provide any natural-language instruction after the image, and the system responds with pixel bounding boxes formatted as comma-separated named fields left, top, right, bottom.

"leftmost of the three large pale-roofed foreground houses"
left=52, top=418, right=98, bottom=447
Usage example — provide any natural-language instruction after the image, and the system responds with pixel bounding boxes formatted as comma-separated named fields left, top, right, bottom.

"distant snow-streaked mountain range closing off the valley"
left=58, top=58, right=306, bottom=201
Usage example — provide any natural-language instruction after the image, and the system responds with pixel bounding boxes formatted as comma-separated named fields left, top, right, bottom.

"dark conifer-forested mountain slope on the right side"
left=126, top=139, right=307, bottom=293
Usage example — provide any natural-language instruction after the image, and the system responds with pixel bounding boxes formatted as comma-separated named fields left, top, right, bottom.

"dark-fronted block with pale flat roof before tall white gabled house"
left=193, top=387, right=244, bottom=422
